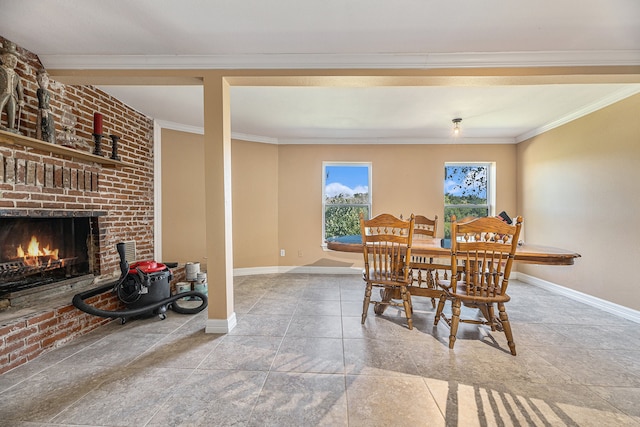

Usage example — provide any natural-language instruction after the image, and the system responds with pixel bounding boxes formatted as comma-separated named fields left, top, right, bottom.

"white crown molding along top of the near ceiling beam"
left=38, top=50, right=640, bottom=70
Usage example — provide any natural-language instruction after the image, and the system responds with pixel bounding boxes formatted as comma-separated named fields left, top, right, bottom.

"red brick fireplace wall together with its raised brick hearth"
left=0, top=36, right=159, bottom=373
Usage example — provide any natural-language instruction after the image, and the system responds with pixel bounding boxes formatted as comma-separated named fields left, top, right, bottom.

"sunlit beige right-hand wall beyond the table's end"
left=517, top=95, right=640, bottom=310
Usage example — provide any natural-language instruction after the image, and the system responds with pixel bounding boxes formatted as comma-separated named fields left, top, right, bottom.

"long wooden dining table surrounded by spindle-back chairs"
left=326, top=235, right=580, bottom=314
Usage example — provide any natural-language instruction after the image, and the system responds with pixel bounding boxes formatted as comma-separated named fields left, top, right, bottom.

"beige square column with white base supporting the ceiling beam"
left=204, top=73, right=236, bottom=333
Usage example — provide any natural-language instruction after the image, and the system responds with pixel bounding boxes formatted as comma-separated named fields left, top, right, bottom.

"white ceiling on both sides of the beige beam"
left=0, top=0, right=640, bottom=143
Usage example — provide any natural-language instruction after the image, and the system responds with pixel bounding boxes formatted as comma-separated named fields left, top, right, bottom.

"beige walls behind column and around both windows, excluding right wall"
left=162, top=131, right=516, bottom=268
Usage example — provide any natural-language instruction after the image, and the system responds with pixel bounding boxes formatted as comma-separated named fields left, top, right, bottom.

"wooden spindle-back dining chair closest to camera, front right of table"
left=434, top=217, right=522, bottom=356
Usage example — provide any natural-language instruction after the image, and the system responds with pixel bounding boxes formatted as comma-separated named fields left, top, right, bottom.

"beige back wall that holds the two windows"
left=278, top=142, right=516, bottom=266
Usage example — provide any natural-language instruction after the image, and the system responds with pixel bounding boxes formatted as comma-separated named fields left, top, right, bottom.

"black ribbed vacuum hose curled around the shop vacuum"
left=72, top=243, right=208, bottom=323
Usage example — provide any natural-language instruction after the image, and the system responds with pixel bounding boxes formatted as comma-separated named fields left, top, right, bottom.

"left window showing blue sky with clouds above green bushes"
left=322, top=162, right=371, bottom=242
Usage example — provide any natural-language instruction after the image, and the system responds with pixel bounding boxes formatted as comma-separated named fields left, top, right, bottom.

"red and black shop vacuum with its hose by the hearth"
left=72, top=243, right=208, bottom=323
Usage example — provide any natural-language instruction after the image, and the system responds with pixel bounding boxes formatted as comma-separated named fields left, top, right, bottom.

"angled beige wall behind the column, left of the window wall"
left=162, top=135, right=279, bottom=270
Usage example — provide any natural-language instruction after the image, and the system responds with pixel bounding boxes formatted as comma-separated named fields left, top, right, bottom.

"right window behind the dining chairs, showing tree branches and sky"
left=444, top=163, right=495, bottom=239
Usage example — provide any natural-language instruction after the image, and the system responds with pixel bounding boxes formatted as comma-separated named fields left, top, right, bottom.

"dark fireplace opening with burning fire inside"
left=0, top=217, right=94, bottom=297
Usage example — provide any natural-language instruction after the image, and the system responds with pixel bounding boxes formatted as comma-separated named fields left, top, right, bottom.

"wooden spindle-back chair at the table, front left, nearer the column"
left=360, top=213, right=414, bottom=329
